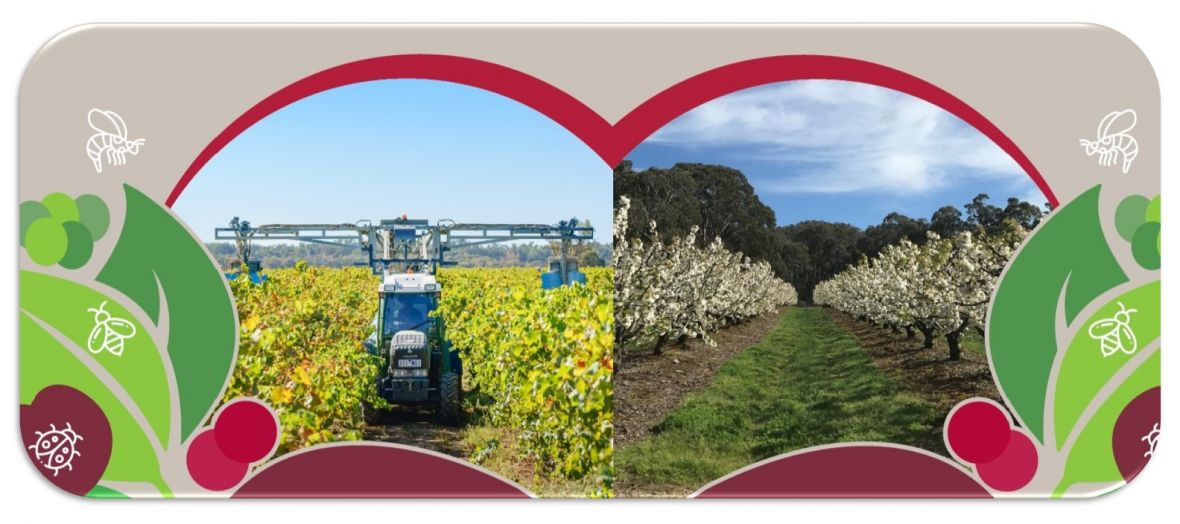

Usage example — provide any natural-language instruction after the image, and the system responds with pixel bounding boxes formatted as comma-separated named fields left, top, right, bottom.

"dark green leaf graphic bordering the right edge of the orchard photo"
left=988, top=186, right=1127, bottom=441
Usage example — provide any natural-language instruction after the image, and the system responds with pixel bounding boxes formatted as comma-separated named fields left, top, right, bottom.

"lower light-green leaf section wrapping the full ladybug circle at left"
left=20, top=311, right=169, bottom=492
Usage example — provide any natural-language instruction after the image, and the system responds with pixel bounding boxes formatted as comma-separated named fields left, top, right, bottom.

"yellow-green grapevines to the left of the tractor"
left=223, top=264, right=381, bottom=454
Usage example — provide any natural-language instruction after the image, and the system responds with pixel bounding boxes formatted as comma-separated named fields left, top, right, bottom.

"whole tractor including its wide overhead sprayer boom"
left=214, top=216, right=594, bottom=423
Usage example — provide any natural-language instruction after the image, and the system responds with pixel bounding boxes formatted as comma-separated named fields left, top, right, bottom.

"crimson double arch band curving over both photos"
left=165, top=54, right=1058, bottom=208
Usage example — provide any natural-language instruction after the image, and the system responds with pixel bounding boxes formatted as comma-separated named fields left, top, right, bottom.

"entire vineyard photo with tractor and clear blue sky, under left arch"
left=173, top=79, right=614, bottom=497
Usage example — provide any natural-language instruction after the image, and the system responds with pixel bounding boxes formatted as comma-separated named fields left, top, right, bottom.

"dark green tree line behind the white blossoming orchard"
left=614, top=161, right=1048, bottom=302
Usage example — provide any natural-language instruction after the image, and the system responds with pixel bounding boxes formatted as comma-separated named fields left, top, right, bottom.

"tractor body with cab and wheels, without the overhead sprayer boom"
left=365, top=273, right=461, bottom=419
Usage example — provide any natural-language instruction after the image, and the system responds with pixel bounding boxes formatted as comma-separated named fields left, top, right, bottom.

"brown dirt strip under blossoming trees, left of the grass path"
left=614, top=308, right=786, bottom=447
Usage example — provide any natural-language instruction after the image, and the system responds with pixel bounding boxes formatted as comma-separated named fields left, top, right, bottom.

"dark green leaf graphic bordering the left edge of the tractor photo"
left=98, top=185, right=236, bottom=440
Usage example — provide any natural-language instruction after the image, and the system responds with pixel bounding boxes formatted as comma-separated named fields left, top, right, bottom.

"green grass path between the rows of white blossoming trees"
left=615, top=308, right=945, bottom=492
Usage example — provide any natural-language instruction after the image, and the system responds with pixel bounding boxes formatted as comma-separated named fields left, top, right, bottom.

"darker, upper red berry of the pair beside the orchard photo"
left=945, top=400, right=1011, bottom=464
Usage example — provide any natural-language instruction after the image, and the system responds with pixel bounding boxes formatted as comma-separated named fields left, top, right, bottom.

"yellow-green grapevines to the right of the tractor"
left=438, top=268, right=615, bottom=496
